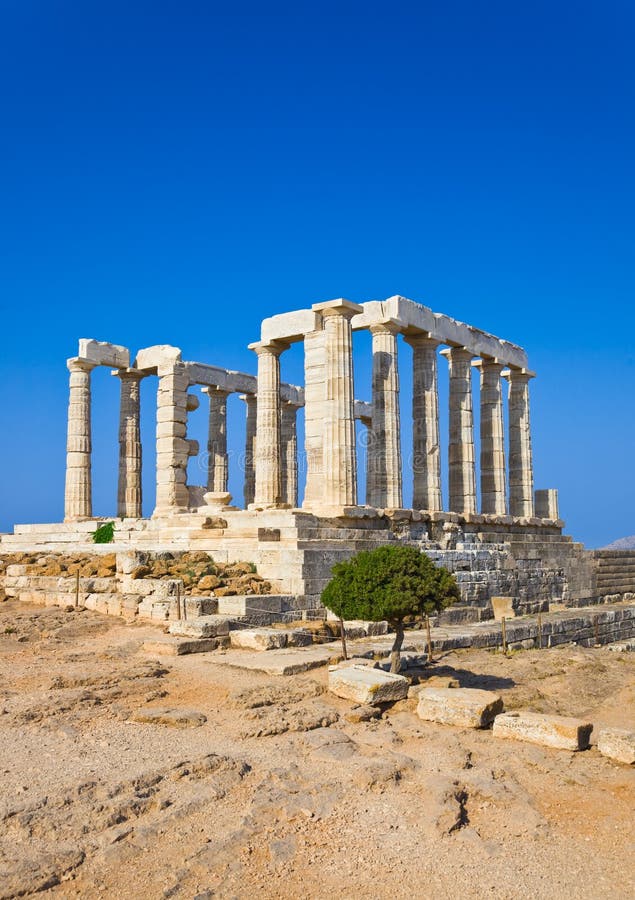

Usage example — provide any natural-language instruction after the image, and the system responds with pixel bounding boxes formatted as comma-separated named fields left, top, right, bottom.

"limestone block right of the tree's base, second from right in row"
left=417, top=687, right=503, bottom=728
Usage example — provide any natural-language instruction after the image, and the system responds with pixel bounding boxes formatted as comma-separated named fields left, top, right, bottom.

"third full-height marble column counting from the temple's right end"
left=441, top=347, right=476, bottom=514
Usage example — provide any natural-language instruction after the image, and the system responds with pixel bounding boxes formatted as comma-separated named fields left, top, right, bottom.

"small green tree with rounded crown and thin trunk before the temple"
left=322, top=544, right=459, bottom=672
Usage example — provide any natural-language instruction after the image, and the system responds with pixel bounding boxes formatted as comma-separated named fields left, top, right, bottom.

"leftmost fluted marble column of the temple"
left=64, top=356, right=95, bottom=521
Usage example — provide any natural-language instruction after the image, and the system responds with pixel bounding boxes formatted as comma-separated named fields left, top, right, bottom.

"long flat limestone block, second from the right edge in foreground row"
left=493, top=711, right=593, bottom=750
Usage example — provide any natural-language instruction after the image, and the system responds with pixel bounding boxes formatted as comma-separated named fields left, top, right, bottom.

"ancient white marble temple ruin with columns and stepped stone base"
left=2, top=296, right=633, bottom=618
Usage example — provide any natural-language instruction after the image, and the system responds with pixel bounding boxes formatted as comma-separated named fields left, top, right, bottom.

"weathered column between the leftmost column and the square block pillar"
left=112, top=369, right=143, bottom=519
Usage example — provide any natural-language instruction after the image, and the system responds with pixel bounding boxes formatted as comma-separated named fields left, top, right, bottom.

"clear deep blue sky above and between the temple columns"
left=0, top=0, right=635, bottom=546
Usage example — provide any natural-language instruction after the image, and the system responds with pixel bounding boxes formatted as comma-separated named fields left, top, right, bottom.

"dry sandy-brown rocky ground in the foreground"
left=0, top=602, right=635, bottom=900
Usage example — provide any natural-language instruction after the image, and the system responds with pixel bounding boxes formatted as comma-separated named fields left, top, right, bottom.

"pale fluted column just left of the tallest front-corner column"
left=249, top=343, right=287, bottom=508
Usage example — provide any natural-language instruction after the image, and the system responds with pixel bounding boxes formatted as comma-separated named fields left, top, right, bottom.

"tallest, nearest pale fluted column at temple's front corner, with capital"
left=313, top=300, right=363, bottom=507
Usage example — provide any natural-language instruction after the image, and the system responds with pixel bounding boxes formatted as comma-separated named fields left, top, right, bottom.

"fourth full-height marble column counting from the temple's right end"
left=405, top=334, right=443, bottom=511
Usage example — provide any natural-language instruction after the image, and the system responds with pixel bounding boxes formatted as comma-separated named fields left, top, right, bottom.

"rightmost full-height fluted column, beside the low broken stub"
left=503, top=369, right=534, bottom=517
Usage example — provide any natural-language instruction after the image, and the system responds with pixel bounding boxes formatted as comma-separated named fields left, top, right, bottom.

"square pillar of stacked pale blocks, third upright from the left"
left=153, top=361, right=192, bottom=517
